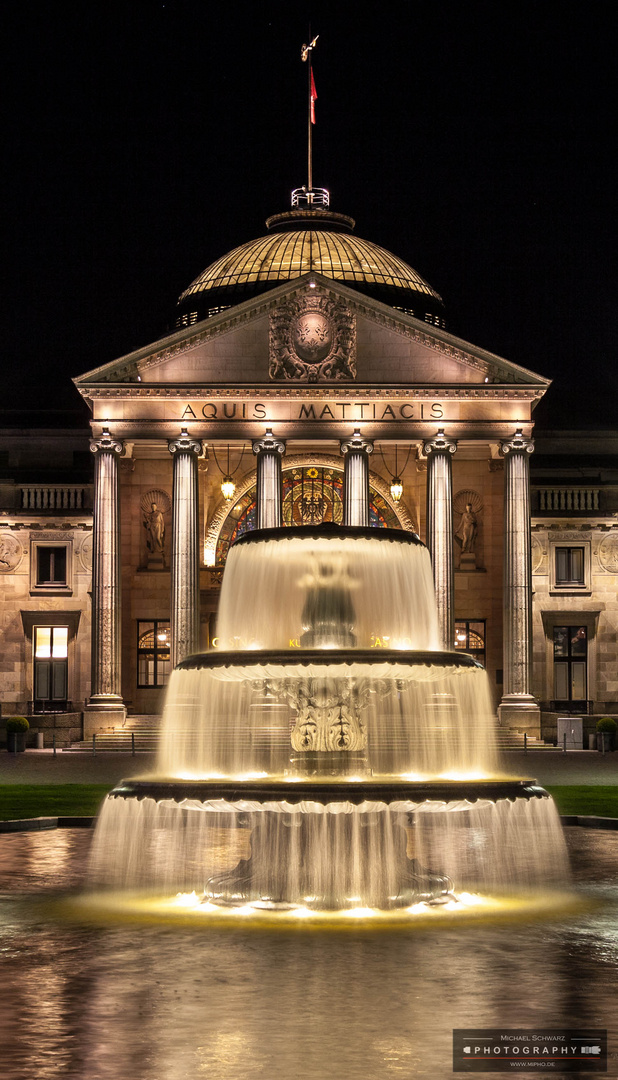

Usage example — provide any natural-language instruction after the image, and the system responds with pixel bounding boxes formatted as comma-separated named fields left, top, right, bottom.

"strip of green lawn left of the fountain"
left=0, top=784, right=112, bottom=821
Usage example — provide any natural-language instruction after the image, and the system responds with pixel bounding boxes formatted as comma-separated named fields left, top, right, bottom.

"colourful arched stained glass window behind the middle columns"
left=216, top=465, right=401, bottom=566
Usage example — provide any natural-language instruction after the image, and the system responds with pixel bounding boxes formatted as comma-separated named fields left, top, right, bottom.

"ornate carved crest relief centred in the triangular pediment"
left=269, top=288, right=357, bottom=382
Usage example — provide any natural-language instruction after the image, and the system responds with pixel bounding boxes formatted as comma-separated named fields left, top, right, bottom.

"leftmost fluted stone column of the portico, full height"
left=84, top=428, right=126, bottom=738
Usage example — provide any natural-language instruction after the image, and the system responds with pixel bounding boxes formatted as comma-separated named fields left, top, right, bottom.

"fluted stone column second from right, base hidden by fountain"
left=422, top=430, right=457, bottom=649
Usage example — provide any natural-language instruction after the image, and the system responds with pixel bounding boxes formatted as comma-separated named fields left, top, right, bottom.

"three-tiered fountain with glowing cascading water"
left=91, top=526, right=566, bottom=912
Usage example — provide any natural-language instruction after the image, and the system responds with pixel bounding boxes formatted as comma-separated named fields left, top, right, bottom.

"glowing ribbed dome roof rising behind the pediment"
left=176, top=196, right=444, bottom=327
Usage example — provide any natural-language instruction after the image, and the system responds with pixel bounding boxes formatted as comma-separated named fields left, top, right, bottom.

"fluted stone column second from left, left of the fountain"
left=167, top=429, right=202, bottom=667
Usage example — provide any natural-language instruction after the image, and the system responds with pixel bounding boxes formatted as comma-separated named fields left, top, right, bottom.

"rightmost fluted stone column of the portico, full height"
left=499, top=430, right=540, bottom=734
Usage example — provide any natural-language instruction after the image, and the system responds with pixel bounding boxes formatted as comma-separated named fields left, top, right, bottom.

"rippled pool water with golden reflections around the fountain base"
left=0, top=829, right=618, bottom=1080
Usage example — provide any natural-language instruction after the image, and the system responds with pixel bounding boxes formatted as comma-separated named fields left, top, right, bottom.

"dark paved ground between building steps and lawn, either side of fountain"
left=0, top=750, right=618, bottom=786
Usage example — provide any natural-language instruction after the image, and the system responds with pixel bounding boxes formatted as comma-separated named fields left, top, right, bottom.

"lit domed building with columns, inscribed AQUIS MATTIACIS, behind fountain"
left=0, top=191, right=618, bottom=737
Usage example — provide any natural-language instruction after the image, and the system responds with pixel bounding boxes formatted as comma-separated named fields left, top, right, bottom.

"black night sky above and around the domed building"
left=0, top=0, right=618, bottom=427
